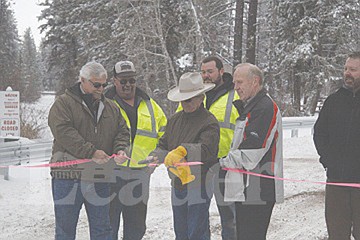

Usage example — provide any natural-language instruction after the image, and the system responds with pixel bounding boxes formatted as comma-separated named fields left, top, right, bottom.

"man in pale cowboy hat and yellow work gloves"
left=148, top=73, right=220, bottom=240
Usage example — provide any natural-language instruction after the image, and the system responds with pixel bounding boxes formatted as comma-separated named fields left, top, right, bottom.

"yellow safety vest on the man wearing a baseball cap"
left=113, top=99, right=167, bottom=168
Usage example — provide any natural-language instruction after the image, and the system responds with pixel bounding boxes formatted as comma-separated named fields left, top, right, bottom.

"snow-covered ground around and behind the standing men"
left=0, top=96, right=332, bottom=240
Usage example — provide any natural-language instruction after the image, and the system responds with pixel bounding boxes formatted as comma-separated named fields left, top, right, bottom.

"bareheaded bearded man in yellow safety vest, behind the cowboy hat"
left=201, top=56, right=239, bottom=240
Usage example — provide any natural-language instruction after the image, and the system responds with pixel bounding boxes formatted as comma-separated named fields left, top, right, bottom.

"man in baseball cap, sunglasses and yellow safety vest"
left=106, top=61, right=167, bottom=240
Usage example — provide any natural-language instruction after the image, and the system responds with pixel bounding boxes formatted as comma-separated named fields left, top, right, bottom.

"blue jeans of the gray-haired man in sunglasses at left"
left=52, top=178, right=112, bottom=240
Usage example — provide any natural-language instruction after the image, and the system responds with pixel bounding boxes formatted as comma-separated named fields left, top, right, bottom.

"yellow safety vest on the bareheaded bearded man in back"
left=176, top=89, right=239, bottom=158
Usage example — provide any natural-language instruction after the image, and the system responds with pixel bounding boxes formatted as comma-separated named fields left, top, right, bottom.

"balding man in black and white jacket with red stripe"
left=220, top=63, right=284, bottom=240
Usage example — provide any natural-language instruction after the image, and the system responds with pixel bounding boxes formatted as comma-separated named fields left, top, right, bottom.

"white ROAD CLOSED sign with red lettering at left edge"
left=0, top=91, right=20, bottom=137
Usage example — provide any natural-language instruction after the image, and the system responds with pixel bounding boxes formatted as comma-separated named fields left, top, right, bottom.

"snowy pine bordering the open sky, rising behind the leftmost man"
left=40, top=0, right=82, bottom=95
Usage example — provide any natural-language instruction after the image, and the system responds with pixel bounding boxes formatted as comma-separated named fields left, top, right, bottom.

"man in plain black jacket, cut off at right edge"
left=314, top=52, right=360, bottom=240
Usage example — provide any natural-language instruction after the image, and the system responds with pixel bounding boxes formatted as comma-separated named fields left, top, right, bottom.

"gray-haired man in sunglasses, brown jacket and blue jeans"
left=48, top=62, right=129, bottom=240
